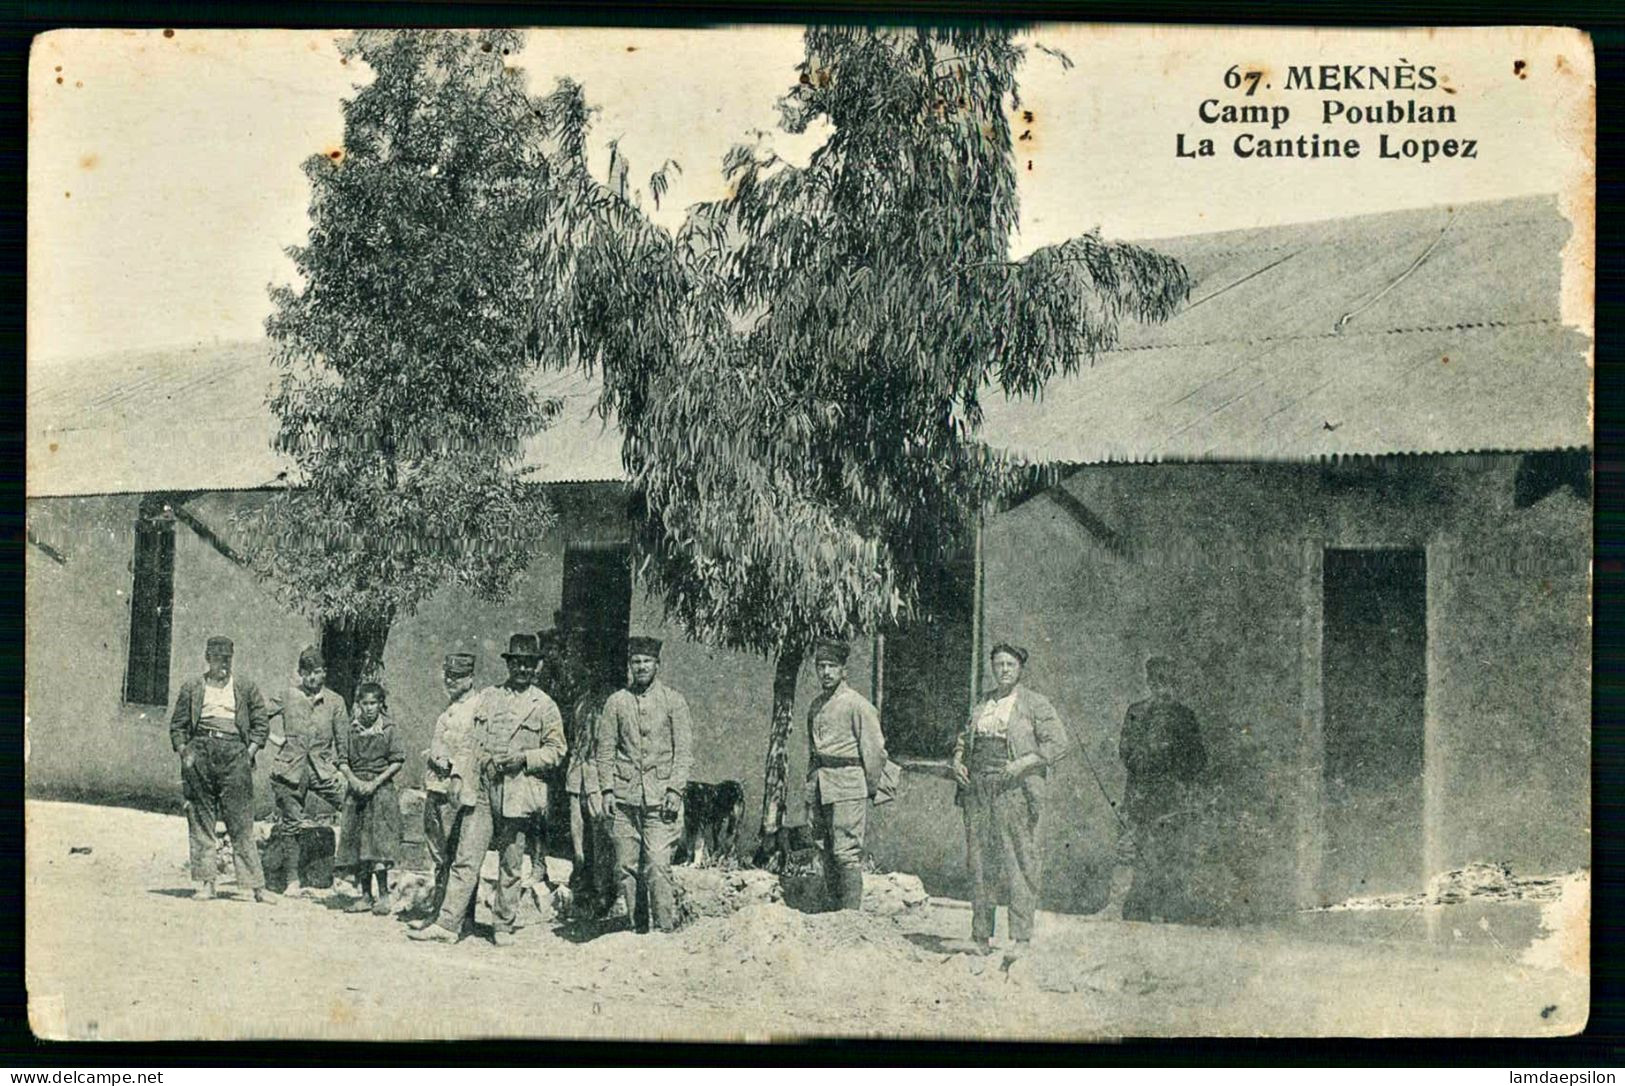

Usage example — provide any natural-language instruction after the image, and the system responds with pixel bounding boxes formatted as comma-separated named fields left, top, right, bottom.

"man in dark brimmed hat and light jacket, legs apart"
left=408, top=634, right=564, bottom=946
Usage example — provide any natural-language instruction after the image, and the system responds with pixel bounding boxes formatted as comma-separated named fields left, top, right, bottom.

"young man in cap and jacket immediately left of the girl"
left=270, top=645, right=349, bottom=897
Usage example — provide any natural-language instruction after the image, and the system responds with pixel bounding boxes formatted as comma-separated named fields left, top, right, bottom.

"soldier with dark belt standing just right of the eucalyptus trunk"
left=806, top=641, right=886, bottom=909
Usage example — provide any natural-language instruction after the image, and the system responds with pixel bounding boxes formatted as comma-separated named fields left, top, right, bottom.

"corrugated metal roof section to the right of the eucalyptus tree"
left=983, top=198, right=1591, bottom=463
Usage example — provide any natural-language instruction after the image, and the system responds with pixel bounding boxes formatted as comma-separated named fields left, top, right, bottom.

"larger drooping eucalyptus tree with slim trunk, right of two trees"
left=572, top=28, right=1190, bottom=858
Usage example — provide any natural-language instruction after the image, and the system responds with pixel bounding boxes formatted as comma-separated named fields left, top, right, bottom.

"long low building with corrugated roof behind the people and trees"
left=28, top=198, right=1591, bottom=919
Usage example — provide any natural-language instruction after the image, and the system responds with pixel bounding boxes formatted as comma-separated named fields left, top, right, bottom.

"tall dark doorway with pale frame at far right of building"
left=1321, top=550, right=1427, bottom=901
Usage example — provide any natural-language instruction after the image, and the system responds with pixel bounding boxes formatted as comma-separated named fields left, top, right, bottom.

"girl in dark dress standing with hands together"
left=336, top=683, right=406, bottom=917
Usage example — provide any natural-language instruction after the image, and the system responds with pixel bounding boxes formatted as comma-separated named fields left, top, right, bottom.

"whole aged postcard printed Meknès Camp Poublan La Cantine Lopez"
left=24, top=24, right=1596, bottom=1040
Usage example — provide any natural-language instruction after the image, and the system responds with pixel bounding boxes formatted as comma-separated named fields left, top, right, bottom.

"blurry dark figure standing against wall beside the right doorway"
left=1118, top=657, right=1207, bottom=920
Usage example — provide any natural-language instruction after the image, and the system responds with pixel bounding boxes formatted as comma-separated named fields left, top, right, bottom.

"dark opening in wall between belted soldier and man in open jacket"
left=881, top=556, right=977, bottom=758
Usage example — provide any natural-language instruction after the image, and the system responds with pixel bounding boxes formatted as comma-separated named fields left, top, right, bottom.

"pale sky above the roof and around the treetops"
left=28, top=26, right=1591, bottom=367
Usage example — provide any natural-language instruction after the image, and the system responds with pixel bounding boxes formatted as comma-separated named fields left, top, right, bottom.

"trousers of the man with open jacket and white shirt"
left=965, top=772, right=1043, bottom=940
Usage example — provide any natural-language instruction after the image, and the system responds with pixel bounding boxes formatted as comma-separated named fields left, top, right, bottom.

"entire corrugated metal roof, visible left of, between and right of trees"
left=28, top=198, right=1591, bottom=496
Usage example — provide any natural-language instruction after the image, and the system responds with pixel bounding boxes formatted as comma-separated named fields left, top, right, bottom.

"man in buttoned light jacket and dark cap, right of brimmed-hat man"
left=592, top=637, right=694, bottom=932
